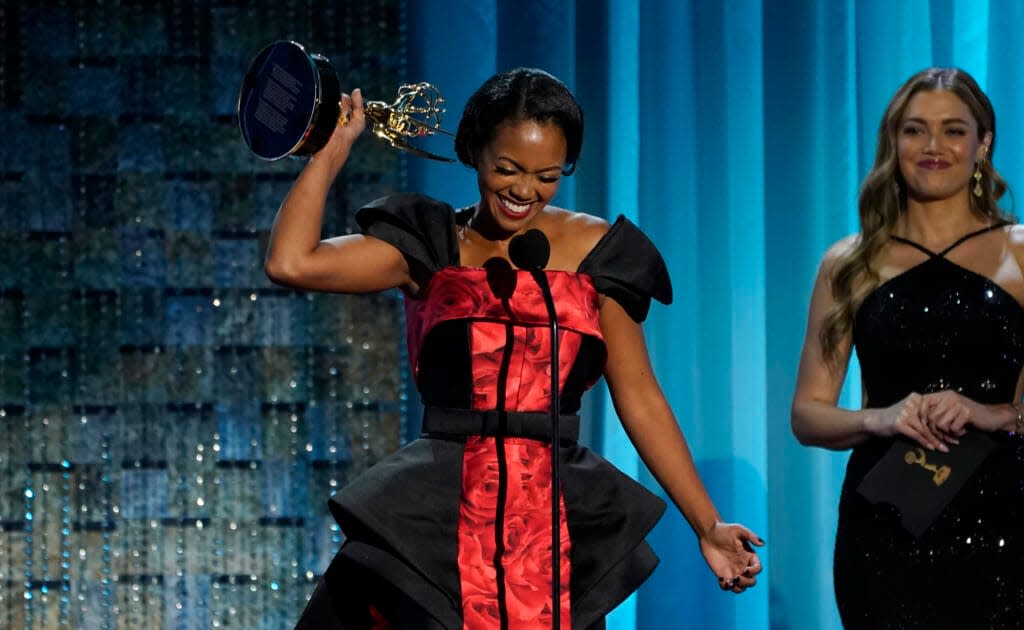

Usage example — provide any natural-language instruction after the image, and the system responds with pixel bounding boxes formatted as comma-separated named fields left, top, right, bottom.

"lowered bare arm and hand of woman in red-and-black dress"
left=601, top=297, right=764, bottom=592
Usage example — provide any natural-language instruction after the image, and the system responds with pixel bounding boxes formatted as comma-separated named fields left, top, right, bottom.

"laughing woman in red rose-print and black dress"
left=266, top=69, right=762, bottom=628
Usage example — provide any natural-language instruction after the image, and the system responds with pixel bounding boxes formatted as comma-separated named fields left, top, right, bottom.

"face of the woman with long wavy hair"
left=896, top=89, right=991, bottom=203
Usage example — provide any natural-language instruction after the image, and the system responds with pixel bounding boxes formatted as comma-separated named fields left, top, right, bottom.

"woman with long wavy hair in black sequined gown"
left=793, top=69, right=1024, bottom=630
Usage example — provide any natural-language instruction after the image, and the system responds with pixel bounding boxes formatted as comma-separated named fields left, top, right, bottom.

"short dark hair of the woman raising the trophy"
left=455, top=68, right=583, bottom=175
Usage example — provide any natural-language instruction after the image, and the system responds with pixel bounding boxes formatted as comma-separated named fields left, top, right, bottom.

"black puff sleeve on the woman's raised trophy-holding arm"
left=355, top=193, right=459, bottom=286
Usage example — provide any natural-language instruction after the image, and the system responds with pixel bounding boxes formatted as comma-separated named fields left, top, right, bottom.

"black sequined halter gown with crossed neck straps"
left=835, top=226, right=1024, bottom=630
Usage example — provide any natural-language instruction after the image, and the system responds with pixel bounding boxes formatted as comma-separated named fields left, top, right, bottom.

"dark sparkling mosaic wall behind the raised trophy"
left=0, top=0, right=406, bottom=629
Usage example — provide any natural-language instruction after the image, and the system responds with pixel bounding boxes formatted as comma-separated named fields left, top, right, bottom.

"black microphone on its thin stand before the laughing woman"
left=509, top=228, right=562, bottom=630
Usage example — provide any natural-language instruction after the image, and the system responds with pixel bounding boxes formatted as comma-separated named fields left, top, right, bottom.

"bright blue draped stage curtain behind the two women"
left=409, top=0, right=1024, bottom=630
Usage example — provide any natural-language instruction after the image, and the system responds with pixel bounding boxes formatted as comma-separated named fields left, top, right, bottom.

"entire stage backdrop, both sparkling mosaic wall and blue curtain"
left=0, top=0, right=1024, bottom=630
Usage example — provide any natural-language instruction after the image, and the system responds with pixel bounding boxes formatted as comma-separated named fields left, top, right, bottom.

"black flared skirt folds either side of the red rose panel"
left=330, top=438, right=666, bottom=629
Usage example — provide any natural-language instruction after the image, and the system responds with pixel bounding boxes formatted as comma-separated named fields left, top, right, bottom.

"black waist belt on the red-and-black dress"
left=423, top=407, right=580, bottom=443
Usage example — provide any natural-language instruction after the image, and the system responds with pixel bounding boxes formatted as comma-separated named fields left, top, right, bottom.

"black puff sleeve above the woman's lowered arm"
left=580, top=215, right=672, bottom=322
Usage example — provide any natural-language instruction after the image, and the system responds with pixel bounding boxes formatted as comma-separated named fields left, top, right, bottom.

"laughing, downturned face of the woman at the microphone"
left=476, top=120, right=566, bottom=234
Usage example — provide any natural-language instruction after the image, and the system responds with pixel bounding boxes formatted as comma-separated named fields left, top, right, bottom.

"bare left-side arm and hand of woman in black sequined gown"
left=791, top=239, right=948, bottom=451
